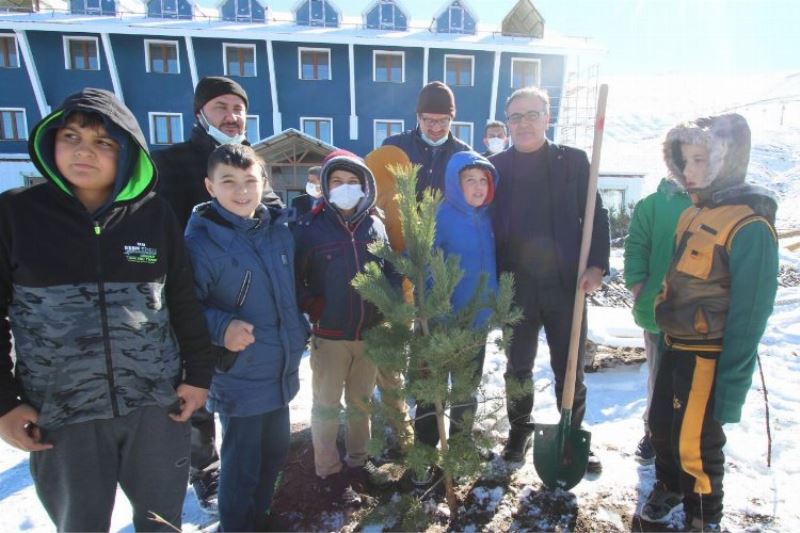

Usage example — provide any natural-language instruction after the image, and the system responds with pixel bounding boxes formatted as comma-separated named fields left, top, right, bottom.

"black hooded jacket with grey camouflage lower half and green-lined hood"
left=0, top=89, right=211, bottom=428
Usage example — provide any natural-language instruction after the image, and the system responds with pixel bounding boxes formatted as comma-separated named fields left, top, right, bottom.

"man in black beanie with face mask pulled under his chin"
left=153, top=76, right=280, bottom=511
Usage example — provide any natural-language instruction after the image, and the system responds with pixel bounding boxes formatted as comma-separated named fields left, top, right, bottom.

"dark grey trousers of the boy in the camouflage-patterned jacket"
left=30, top=406, right=189, bottom=531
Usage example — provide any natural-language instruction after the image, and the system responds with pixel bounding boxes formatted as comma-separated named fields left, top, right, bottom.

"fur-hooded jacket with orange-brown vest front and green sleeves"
left=655, top=114, right=778, bottom=423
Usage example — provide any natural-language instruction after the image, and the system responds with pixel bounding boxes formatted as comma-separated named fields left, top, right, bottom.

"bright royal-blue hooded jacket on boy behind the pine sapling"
left=435, top=152, right=500, bottom=325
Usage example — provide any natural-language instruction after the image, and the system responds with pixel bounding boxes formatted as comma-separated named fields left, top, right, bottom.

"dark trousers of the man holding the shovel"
left=505, top=274, right=586, bottom=432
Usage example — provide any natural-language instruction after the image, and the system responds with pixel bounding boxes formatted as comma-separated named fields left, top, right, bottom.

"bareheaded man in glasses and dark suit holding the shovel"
left=489, top=87, right=609, bottom=472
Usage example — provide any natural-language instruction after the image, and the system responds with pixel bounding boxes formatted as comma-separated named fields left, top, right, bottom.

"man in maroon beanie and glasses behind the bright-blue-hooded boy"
left=383, top=81, right=472, bottom=195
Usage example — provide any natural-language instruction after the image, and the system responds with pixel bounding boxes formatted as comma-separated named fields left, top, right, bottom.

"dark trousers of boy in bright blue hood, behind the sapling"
left=414, top=346, right=486, bottom=448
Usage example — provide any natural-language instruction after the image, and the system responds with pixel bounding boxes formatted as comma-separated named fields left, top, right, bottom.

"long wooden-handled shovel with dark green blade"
left=533, top=84, right=608, bottom=490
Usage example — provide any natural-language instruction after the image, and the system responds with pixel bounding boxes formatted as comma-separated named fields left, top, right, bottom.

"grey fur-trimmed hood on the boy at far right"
left=664, top=113, right=750, bottom=200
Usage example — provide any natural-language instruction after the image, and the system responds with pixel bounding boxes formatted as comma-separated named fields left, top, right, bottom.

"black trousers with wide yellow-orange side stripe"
left=648, top=347, right=726, bottom=523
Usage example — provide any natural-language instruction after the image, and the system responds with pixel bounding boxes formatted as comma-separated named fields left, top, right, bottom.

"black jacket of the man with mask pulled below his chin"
left=153, top=122, right=283, bottom=229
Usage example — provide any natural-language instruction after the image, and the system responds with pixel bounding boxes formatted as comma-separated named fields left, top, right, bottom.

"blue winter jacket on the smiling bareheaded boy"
left=186, top=200, right=309, bottom=416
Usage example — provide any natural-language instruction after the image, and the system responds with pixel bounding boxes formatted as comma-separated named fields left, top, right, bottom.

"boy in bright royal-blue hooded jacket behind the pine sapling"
left=414, top=151, right=500, bottom=472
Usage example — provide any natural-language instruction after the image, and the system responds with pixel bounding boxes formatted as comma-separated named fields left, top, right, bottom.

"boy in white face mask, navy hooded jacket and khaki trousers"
left=294, top=151, right=400, bottom=490
